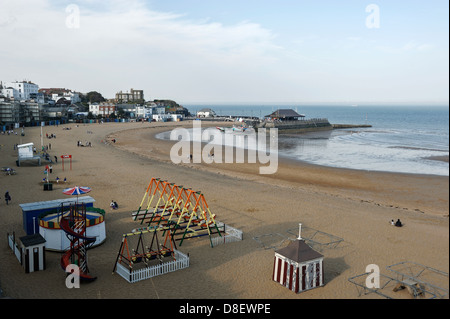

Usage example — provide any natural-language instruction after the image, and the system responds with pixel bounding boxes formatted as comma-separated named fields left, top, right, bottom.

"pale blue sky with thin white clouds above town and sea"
left=0, top=0, right=449, bottom=104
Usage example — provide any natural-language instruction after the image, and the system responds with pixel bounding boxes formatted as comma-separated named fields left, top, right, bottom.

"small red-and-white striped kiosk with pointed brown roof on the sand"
left=272, top=224, right=324, bottom=293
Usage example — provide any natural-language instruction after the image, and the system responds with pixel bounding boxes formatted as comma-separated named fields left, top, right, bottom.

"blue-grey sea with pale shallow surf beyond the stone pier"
left=171, top=104, right=449, bottom=176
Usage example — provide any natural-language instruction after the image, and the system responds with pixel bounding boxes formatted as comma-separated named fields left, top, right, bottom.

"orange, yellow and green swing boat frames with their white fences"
left=113, top=178, right=242, bottom=283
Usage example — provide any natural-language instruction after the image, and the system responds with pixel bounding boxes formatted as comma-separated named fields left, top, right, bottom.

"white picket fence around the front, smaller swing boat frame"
left=116, top=250, right=189, bottom=283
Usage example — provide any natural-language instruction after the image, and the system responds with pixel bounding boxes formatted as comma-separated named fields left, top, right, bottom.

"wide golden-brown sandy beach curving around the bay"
left=0, top=122, right=449, bottom=299
